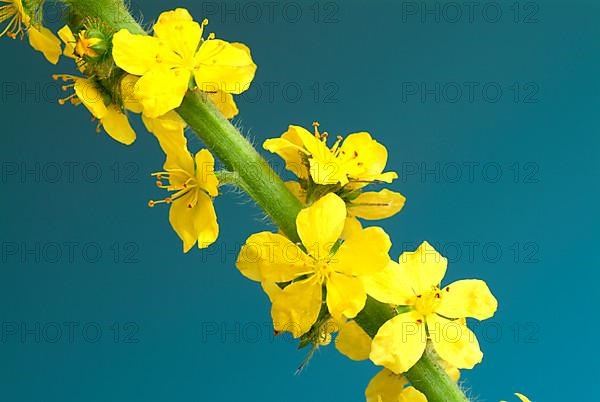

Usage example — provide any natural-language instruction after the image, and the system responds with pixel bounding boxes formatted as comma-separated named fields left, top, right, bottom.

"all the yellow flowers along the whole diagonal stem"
left=0, top=0, right=529, bottom=402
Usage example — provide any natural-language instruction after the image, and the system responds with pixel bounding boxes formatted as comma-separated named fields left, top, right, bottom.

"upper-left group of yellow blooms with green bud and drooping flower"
left=48, top=7, right=256, bottom=252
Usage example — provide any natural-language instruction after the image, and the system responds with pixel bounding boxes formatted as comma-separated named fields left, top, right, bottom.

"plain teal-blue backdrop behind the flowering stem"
left=0, top=0, right=600, bottom=402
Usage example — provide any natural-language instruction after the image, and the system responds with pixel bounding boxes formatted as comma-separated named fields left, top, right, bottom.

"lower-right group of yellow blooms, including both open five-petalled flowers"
left=237, top=123, right=497, bottom=401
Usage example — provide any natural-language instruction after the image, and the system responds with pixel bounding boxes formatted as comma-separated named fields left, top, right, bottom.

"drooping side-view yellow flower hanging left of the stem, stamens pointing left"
left=148, top=126, right=219, bottom=253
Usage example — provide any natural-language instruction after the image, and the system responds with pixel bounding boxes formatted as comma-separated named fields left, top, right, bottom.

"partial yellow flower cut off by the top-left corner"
left=0, top=0, right=62, bottom=64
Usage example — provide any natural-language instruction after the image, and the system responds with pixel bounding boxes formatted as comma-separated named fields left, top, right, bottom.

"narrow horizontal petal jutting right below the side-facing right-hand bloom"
left=348, top=190, right=406, bottom=220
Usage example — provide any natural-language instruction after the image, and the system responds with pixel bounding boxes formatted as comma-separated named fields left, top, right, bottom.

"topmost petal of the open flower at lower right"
left=400, top=241, right=448, bottom=294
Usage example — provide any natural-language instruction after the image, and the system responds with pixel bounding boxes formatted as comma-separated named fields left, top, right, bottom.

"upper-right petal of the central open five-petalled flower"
left=331, top=227, right=392, bottom=275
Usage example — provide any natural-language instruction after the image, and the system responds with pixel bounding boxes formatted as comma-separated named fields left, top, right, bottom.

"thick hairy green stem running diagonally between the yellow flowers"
left=63, top=0, right=468, bottom=402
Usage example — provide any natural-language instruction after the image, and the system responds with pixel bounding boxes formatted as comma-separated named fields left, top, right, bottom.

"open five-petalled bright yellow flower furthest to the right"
left=363, top=242, right=498, bottom=373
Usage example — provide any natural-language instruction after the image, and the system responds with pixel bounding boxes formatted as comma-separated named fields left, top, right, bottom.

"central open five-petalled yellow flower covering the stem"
left=237, top=193, right=391, bottom=337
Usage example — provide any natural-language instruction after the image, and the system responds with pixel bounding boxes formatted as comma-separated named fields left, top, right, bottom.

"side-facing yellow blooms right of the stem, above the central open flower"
left=263, top=122, right=406, bottom=237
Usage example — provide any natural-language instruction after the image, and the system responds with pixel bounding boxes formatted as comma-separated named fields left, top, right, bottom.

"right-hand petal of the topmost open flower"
left=194, top=39, right=256, bottom=94
